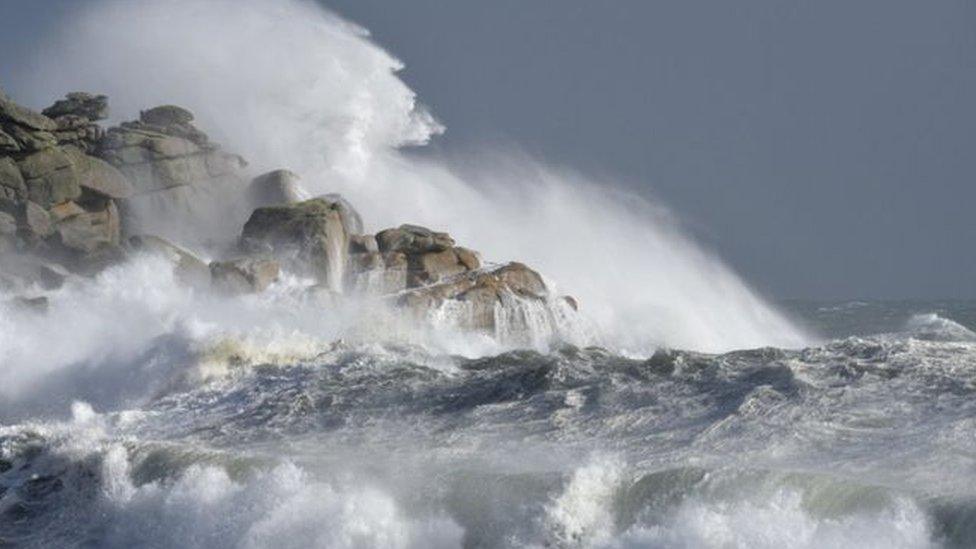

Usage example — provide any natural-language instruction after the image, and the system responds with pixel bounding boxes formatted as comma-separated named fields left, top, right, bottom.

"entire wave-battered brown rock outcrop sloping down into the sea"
left=0, top=91, right=577, bottom=335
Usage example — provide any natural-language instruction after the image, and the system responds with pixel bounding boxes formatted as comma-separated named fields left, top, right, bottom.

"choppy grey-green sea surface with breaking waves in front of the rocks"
left=0, top=301, right=976, bottom=548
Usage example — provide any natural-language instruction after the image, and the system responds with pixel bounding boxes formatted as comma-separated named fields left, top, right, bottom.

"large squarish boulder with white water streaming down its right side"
left=241, top=197, right=354, bottom=290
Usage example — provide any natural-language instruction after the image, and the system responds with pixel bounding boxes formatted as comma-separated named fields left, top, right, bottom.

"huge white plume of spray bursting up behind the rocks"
left=9, top=0, right=805, bottom=352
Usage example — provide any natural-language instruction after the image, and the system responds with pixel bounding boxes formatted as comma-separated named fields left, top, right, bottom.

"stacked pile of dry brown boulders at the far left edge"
left=0, top=93, right=130, bottom=273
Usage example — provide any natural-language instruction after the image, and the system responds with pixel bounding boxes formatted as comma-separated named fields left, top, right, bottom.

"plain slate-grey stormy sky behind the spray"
left=0, top=0, right=976, bottom=299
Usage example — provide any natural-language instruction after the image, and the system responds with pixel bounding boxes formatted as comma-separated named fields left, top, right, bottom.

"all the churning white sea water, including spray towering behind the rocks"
left=0, top=0, right=976, bottom=549
